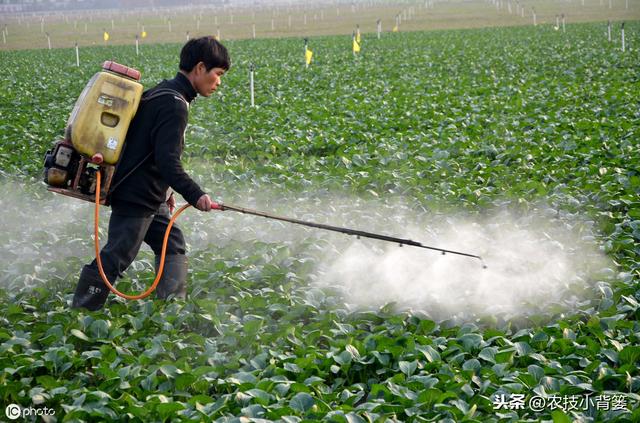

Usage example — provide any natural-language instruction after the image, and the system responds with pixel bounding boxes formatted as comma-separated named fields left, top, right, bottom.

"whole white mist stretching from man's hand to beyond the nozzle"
left=171, top=172, right=615, bottom=320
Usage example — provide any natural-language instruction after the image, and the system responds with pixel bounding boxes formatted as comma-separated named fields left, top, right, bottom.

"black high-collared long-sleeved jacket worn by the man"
left=110, top=73, right=204, bottom=215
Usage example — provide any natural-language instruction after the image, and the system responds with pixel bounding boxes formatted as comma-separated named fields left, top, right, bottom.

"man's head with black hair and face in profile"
left=180, top=37, right=231, bottom=97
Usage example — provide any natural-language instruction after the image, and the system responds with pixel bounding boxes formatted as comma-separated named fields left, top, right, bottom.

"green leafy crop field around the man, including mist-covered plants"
left=0, top=21, right=640, bottom=422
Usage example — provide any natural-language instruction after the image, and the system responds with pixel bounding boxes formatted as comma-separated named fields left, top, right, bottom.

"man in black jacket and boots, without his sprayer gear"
left=72, top=37, right=231, bottom=310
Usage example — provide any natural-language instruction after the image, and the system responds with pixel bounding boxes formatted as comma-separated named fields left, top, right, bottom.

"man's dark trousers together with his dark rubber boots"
left=72, top=204, right=186, bottom=310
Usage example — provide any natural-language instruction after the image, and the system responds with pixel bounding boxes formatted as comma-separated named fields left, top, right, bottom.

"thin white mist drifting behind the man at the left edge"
left=0, top=178, right=101, bottom=292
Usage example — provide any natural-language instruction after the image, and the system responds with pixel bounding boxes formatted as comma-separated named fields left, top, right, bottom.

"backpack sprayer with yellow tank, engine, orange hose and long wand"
left=44, top=61, right=487, bottom=299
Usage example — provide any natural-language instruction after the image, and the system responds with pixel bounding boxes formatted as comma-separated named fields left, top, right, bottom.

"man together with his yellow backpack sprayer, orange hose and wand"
left=45, top=37, right=484, bottom=310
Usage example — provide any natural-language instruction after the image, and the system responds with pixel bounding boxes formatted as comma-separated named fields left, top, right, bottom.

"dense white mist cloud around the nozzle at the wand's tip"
left=317, top=206, right=613, bottom=319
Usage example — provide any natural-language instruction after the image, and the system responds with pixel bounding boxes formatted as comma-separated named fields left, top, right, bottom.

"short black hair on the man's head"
left=180, top=36, right=231, bottom=72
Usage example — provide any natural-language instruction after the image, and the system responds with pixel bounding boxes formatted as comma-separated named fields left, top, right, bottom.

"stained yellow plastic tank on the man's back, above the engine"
left=66, top=61, right=142, bottom=165
